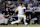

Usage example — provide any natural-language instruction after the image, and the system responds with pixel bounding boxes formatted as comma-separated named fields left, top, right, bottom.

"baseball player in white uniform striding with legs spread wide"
left=11, top=4, right=28, bottom=25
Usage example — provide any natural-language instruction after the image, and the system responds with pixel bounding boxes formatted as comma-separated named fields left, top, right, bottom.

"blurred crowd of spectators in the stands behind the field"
left=0, top=0, right=40, bottom=10
